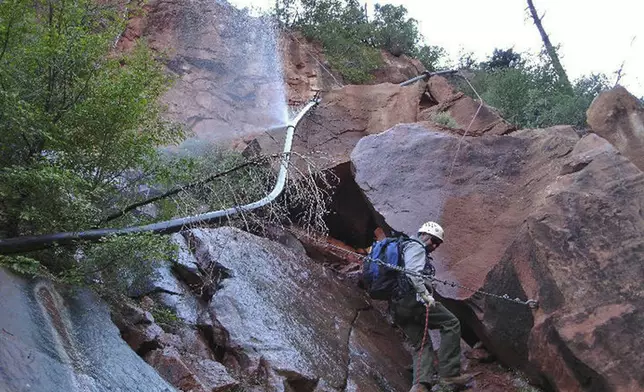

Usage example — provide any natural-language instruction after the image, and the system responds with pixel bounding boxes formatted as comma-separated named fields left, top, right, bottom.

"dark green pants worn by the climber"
left=391, top=294, right=461, bottom=384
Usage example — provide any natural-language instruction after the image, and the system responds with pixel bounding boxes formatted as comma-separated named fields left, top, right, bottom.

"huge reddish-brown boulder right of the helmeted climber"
left=352, top=124, right=644, bottom=391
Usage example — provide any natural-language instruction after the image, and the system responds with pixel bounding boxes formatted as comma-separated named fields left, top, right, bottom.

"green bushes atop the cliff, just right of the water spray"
left=273, top=0, right=445, bottom=84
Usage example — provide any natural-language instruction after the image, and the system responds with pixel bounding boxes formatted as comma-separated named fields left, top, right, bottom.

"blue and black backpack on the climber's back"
left=362, top=235, right=416, bottom=300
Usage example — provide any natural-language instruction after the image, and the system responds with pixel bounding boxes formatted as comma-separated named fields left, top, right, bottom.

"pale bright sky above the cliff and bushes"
left=229, top=0, right=644, bottom=97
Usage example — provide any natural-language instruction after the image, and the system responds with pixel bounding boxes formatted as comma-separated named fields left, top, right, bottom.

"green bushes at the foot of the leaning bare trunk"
left=460, top=50, right=608, bottom=128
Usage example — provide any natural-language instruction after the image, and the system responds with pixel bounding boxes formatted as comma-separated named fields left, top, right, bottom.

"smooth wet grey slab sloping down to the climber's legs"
left=186, top=228, right=409, bottom=390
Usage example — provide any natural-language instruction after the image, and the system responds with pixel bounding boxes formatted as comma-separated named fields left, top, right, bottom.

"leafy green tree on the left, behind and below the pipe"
left=0, top=0, right=183, bottom=287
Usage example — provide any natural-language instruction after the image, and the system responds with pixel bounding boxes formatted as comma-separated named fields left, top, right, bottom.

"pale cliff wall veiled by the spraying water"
left=120, top=0, right=287, bottom=143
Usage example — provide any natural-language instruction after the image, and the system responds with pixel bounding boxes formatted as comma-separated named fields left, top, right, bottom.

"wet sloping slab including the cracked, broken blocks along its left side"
left=119, top=228, right=411, bottom=391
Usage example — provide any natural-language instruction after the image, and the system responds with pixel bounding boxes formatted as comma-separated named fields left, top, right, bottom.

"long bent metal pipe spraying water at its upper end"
left=0, top=97, right=320, bottom=255
